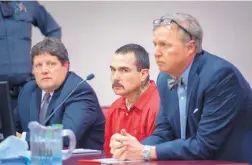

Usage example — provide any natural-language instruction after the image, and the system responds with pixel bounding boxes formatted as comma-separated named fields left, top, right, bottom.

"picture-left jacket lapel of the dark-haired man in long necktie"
left=30, top=87, right=42, bottom=121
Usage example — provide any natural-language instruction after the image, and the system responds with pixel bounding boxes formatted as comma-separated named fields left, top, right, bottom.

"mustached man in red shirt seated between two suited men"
left=104, top=44, right=160, bottom=156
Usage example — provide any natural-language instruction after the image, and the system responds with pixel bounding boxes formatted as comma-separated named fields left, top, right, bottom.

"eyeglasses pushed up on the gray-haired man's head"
left=153, top=17, right=193, bottom=40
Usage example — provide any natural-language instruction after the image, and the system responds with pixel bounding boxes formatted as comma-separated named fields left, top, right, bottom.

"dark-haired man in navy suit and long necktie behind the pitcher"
left=15, top=38, right=105, bottom=149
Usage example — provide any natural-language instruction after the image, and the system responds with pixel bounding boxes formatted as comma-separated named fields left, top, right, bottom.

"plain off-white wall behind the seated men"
left=33, top=1, right=252, bottom=105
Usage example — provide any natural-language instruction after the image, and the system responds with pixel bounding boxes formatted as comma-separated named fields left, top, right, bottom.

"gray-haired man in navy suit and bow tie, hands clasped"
left=110, top=13, right=252, bottom=163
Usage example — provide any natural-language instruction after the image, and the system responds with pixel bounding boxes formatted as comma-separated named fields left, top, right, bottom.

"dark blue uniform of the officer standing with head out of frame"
left=0, top=1, right=61, bottom=109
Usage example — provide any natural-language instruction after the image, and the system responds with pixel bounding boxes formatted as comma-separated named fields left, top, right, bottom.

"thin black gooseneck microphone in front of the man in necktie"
left=43, top=73, right=95, bottom=125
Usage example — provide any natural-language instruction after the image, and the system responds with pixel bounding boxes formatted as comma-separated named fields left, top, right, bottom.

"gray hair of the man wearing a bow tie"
left=154, top=13, right=203, bottom=53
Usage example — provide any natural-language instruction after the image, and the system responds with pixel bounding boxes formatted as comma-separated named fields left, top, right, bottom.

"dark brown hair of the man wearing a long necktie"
left=31, top=37, right=69, bottom=64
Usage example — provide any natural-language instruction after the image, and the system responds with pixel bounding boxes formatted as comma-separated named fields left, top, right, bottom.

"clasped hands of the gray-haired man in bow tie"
left=109, top=129, right=144, bottom=160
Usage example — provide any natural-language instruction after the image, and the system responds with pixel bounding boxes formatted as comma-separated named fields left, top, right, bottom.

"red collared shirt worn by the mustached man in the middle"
left=104, top=80, right=160, bottom=156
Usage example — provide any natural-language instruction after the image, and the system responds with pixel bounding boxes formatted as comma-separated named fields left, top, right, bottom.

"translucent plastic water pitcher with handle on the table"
left=28, top=121, right=76, bottom=165
